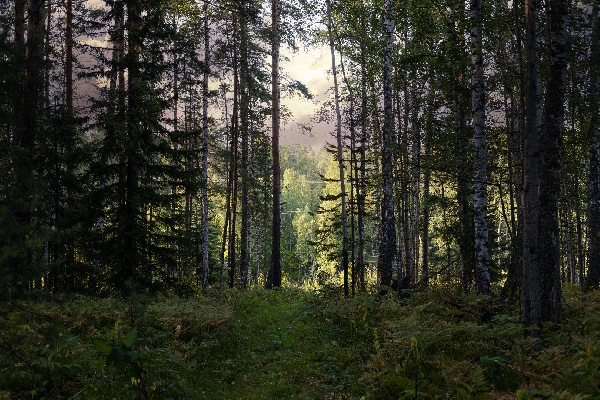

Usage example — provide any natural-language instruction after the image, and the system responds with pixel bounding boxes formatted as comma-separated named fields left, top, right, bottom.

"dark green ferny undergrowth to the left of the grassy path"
left=0, top=296, right=231, bottom=398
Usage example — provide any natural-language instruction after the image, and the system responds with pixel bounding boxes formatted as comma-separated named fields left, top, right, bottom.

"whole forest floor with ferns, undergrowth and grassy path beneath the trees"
left=0, top=287, right=600, bottom=399
